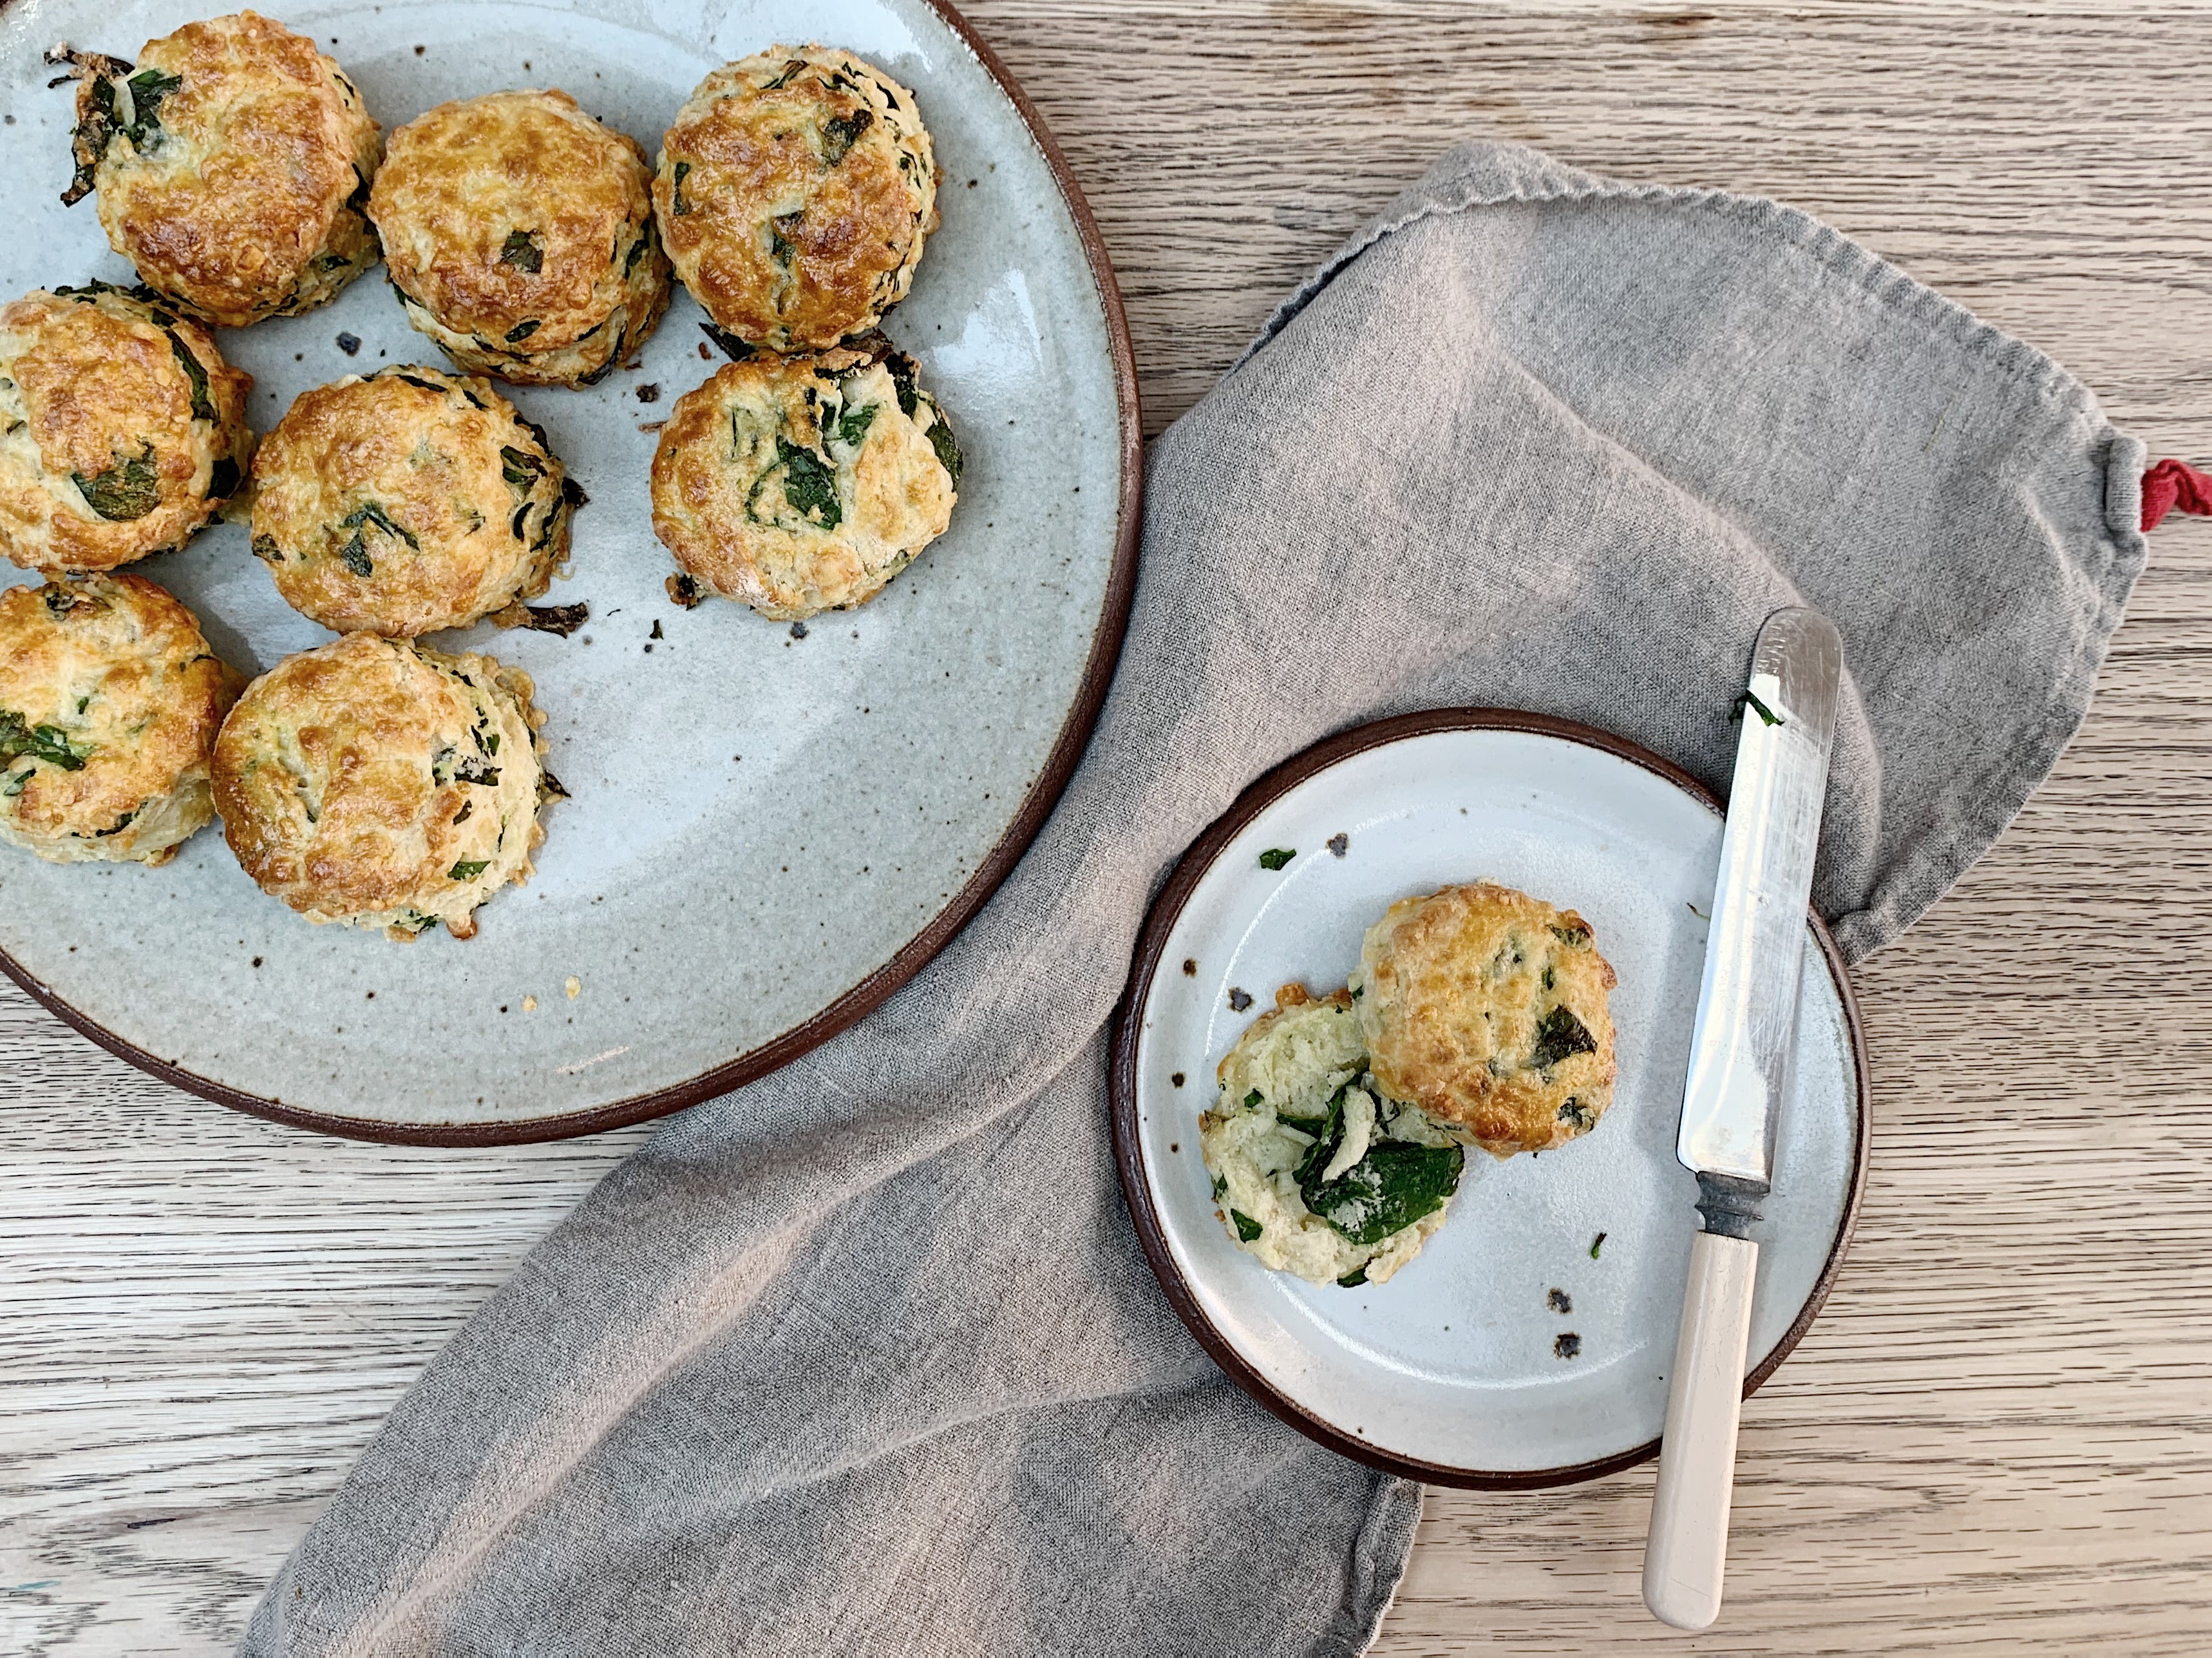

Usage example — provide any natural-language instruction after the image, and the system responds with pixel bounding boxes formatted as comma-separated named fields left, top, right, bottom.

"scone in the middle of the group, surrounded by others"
left=252, top=367, right=581, bottom=638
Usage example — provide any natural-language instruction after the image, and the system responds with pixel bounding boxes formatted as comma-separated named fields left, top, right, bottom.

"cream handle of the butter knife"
left=1643, top=1233, right=1759, bottom=1629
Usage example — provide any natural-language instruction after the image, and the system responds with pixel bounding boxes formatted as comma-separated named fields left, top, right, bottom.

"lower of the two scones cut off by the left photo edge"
left=0, top=576, right=243, bottom=863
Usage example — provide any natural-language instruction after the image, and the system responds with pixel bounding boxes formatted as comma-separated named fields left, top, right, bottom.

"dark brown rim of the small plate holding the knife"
left=1106, top=709, right=1869, bottom=1492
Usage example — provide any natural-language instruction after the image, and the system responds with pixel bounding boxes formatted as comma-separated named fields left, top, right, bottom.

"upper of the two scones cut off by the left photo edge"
left=0, top=281, right=254, bottom=573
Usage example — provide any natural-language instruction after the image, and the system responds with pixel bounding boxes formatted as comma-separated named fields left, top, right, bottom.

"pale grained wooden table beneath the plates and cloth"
left=0, top=0, right=2212, bottom=1658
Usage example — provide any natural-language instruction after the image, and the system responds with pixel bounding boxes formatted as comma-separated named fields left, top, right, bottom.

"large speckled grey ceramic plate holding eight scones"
left=0, top=0, right=1139, bottom=1142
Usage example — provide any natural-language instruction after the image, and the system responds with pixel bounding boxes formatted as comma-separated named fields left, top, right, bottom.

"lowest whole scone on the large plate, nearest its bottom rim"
left=214, top=633, right=560, bottom=939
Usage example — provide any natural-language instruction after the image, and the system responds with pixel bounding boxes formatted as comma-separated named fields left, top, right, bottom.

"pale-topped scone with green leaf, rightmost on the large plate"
left=652, top=336, right=960, bottom=622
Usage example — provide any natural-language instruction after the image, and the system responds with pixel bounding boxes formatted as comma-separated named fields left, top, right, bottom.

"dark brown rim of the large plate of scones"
left=0, top=0, right=1144, bottom=1147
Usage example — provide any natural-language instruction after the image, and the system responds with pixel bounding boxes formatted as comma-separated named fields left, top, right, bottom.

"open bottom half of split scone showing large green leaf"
left=1199, top=985, right=1466, bottom=1288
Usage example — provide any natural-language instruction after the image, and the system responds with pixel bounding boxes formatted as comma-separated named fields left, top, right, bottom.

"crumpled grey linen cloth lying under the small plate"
left=245, top=146, right=2144, bottom=1658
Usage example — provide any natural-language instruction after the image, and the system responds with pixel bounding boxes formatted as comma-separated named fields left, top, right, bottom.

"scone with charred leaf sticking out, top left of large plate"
left=49, top=11, right=383, bottom=328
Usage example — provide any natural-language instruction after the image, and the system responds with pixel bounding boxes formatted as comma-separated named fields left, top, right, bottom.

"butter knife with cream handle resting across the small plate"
left=1643, top=609, right=1842, bottom=1629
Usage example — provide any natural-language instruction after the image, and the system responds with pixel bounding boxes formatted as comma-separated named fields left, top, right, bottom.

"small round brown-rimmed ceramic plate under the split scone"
left=1110, top=709, right=1867, bottom=1487
